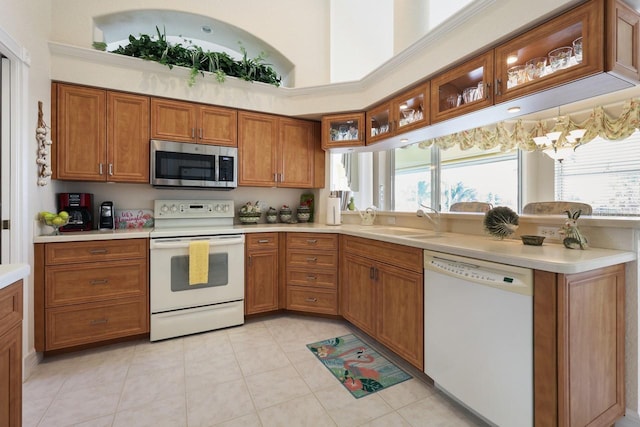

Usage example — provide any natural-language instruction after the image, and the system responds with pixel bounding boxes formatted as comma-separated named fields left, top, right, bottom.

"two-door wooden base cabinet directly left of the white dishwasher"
left=340, top=236, right=424, bottom=371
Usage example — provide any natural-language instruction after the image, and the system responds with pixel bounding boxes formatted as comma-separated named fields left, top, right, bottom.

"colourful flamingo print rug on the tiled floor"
left=307, top=334, right=411, bottom=399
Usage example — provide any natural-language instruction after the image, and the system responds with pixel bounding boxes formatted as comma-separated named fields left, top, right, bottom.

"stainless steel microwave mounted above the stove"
left=150, top=139, right=238, bottom=190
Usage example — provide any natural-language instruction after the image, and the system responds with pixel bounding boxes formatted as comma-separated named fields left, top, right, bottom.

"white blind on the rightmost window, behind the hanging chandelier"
left=555, top=131, right=640, bottom=216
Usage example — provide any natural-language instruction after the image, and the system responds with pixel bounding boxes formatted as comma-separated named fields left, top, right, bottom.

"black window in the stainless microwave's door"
left=156, top=151, right=216, bottom=181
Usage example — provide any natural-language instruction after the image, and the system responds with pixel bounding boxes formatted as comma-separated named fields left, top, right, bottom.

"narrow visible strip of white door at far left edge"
left=0, top=54, right=11, bottom=264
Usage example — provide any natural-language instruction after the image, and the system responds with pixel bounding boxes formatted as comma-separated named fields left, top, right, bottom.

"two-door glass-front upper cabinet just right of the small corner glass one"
left=366, top=82, right=430, bottom=145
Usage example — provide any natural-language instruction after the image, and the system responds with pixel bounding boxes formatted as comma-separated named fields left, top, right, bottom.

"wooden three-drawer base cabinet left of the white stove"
left=34, top=239, right=149, bottom=351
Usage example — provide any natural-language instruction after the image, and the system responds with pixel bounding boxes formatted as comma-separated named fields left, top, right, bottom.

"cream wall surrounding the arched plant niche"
left=50, top=0, right=329, bottom=87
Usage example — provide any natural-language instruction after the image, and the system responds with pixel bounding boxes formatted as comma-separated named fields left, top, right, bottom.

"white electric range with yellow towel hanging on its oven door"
left=149, top=200, right=244, bottom=341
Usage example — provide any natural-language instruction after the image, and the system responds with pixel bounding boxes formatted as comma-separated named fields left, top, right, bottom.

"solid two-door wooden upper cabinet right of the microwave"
left=238, top=111, right=324, bottom=188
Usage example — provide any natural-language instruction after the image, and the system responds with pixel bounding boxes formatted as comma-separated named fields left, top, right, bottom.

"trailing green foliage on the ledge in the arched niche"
left=93, top=27, right=282, bottom=86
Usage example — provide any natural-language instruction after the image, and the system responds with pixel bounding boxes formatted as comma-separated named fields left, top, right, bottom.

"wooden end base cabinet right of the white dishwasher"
left=534, top=265, right=625, bottom=427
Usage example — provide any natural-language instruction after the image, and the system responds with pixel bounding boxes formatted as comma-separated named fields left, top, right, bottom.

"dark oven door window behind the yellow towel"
left=171, top=253, right=229, bottom=292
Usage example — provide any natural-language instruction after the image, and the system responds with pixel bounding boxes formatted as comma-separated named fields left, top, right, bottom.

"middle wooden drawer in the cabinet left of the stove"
left=45, top=260, right=147, bottom=307
